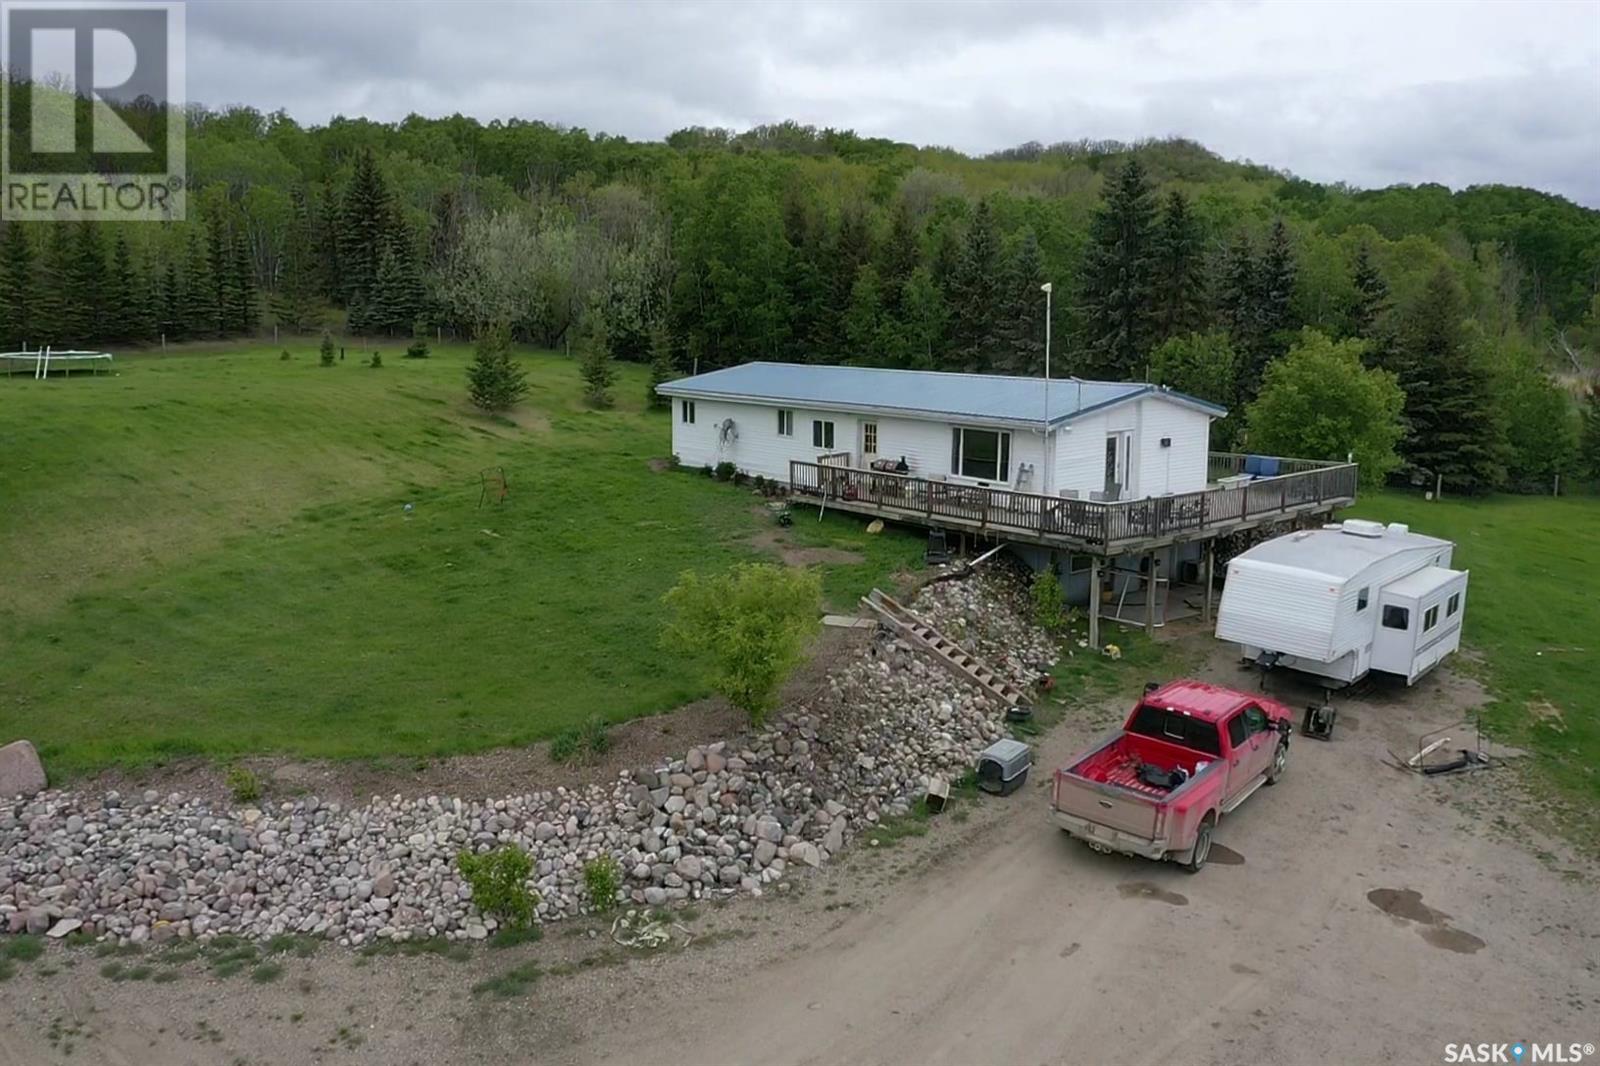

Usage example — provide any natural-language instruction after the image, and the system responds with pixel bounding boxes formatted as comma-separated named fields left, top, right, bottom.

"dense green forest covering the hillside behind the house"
left=0, top=107, right=1600, bottom=490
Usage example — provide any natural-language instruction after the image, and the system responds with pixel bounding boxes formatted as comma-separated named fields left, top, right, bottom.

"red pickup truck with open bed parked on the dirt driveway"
left=1051, top=680, right=1291, bottom=872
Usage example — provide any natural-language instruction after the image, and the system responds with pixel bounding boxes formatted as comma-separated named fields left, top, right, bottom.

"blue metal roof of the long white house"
left=658, top=356, right=1227, bottom=426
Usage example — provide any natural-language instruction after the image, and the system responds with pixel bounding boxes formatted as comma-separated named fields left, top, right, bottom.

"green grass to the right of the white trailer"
left=1349, top=493, right=1600, bottom=810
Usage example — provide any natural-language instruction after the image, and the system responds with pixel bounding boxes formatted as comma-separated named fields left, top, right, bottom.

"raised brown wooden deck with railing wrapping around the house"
left=789, top=453, right=1357, bottom=557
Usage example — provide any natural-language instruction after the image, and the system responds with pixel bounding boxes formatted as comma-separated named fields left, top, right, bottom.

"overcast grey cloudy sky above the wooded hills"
left=189, top=0, right=1600, bottom=206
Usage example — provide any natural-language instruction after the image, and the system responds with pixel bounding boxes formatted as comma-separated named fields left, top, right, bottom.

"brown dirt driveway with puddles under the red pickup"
left=0, top=642, right=1600, bottom=1066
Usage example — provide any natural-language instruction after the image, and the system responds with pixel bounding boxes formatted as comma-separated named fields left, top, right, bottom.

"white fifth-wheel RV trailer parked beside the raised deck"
left=1216, top=519, right=1467, bottom=685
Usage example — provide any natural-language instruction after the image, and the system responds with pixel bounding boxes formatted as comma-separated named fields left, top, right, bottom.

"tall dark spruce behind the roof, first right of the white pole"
left=1078, top=158, right=1155, bottom=379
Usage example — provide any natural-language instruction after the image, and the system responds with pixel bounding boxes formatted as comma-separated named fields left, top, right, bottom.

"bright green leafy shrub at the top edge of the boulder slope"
left=662, top=563, right=822, bottom=723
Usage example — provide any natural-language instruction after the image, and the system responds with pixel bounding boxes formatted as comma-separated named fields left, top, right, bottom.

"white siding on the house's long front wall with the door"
left=672, top=397, right=1043, bottom=491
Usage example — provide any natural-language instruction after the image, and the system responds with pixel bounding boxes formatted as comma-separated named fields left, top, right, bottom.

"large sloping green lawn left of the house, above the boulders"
left=0, top=341, right=922, bottom=775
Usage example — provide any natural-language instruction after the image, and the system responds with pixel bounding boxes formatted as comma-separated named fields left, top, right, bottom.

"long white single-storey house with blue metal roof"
left=658, top=363, right=1227, bottom=501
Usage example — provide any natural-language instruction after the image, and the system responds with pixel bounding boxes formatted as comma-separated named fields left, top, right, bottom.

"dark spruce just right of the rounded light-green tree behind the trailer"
left=1400, top=267, right=1504, bottom=493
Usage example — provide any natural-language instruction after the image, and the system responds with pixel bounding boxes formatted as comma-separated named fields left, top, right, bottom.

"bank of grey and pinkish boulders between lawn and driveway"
left=0, top=568, right=1053, bottom=944
